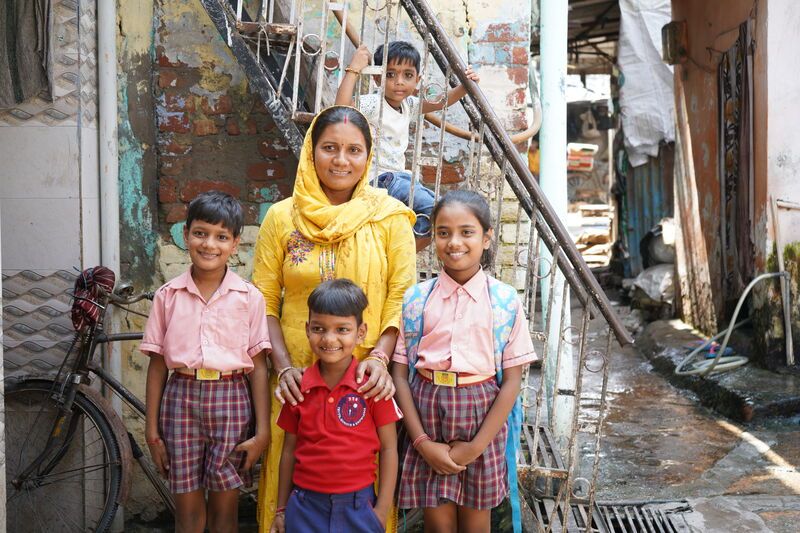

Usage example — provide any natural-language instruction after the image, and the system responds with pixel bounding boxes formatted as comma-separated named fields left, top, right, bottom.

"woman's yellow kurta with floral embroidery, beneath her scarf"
left=253, top=198, right=416, bottom=531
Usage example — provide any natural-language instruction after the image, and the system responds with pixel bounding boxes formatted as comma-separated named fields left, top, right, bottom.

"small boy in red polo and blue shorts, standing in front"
left=270, top=279, right=402, bottom=533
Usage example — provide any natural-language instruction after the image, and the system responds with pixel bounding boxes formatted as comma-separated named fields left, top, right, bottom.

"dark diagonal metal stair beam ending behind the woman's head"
left=200, top=0, right=304, bottom=157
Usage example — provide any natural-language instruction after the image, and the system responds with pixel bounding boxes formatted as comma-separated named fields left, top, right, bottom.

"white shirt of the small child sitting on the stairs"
left=358, top=94, right=419, bottom=179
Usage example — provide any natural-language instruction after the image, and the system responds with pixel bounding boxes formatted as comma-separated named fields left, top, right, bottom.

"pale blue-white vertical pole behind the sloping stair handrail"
left=539, top=0, right=575, bottom=438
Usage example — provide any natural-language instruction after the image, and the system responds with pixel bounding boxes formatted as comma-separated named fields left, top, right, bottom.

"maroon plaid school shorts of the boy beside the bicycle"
left=159, top=373, right=253, bottom=494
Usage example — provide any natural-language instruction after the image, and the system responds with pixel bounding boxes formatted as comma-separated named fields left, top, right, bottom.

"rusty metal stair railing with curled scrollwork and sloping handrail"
left=201, top=0, right=632, bottom=531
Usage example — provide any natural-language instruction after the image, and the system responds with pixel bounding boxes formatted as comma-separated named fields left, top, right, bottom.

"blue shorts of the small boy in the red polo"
left=285, top=485, right=386, bottom=533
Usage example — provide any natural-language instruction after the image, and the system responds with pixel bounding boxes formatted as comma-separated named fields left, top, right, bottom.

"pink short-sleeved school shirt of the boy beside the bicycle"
left=139, top=269, right=272, bottom=372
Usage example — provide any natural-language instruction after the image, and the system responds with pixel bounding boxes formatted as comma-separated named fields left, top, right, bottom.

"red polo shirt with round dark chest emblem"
left=278, top=358, right=403, bottom=494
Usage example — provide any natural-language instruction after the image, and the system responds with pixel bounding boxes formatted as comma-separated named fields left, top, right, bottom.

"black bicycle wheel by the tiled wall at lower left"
left=5, top=380, right=122, bottom=533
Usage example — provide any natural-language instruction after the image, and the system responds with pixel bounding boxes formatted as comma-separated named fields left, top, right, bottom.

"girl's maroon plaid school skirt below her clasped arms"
left=397, top=375, right=508, bottom=509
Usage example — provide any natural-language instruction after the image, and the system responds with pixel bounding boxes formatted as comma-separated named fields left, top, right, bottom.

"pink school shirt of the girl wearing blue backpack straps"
left=392, top=270, right=536, bottom=376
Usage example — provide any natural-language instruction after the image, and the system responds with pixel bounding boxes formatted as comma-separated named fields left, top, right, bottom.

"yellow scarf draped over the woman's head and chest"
left=292, top=106, right=416, bottom=347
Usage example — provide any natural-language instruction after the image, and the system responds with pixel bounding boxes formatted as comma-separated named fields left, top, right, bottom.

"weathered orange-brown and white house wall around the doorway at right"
left=673, top=0, right=800, bottom=368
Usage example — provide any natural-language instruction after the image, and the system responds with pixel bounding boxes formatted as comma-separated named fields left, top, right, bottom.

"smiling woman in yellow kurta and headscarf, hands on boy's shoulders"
left=253, top=106, right=415, bottom=532
